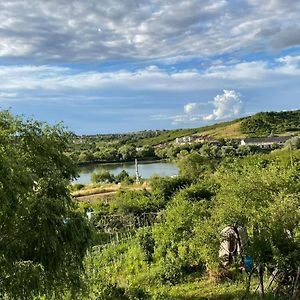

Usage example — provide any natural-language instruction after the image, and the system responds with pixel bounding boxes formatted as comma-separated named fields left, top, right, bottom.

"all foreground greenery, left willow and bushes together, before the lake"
left=0, top=112, right=300, bottom=300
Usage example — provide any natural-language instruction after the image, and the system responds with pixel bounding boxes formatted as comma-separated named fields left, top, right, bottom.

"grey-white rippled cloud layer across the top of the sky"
left=0, top=0, right=300, bottom=62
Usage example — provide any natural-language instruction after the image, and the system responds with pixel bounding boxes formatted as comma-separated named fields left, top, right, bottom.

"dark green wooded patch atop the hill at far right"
left=241, top=110, right=300, bottom=136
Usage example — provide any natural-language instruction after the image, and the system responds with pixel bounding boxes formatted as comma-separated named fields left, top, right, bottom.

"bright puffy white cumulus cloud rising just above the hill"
left=203, top=90, right=243, bottom=121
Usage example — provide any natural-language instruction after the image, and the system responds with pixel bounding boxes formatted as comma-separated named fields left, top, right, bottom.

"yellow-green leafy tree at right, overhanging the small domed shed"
left=198, top=156, right=300, bottom=294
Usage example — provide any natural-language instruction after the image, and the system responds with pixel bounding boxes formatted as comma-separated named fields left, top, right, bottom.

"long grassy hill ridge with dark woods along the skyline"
left=78, top=110, right=300, bottom=148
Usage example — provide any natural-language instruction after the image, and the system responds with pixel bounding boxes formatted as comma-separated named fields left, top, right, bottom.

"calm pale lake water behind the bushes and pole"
left=76, top=162, right=178, bottom=184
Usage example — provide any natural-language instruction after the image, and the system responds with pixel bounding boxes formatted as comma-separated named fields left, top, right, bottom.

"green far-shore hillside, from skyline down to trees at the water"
left=69, top=110, right=300, bottom=163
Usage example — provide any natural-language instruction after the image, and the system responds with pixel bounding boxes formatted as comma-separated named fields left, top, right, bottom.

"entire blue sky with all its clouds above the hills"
left=0, top=0, right=300, bottom=134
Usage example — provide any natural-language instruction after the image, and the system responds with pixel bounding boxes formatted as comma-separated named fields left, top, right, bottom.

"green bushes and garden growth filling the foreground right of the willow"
left=75, top=149, right=300, bottom=299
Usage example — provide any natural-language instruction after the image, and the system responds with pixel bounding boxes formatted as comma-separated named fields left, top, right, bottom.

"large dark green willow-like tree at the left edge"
left=0, top=111, right=90, bottom=299
